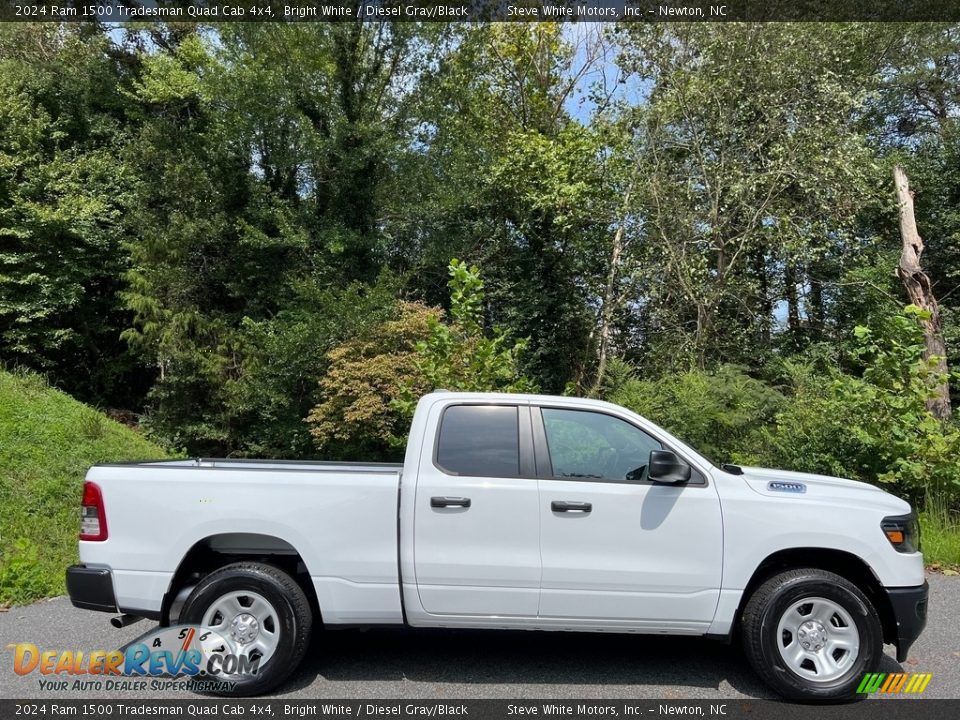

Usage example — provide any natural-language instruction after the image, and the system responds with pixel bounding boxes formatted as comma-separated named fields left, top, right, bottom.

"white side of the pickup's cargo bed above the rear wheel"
left=80, top=458, right=403, bottom=624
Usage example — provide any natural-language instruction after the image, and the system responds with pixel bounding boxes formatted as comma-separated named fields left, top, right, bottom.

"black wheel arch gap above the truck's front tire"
left=731, top=547, right=897, bottom=644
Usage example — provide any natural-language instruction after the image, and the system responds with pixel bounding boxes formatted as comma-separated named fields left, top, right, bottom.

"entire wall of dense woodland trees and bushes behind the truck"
left=0, top=23, right=960, bottom=532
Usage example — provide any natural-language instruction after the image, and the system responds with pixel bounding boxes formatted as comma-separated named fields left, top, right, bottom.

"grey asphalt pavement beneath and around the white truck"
left=0, top=575, right=960, bottom=700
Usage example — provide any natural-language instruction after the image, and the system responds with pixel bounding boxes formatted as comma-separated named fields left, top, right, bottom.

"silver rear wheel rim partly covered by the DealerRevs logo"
left=200, top=590, right=280, bottom=668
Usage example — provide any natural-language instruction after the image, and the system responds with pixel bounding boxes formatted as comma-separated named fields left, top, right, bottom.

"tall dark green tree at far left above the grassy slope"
left=0, top=24, right=143, bottom=403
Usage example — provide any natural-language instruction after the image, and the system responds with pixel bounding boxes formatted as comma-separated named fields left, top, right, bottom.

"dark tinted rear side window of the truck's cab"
left=437, top=405, right=520, bottom=477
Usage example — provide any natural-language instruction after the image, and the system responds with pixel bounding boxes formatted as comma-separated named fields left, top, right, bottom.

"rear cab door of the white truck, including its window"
left=414, top=403, right=541, bottom=617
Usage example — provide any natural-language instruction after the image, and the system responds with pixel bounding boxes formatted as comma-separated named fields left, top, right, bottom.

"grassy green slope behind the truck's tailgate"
left=0, top=370, right=168, bottom=605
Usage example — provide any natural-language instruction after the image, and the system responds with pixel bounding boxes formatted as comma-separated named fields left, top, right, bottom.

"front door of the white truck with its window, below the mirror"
left=532, top=407, right=723, bottom=632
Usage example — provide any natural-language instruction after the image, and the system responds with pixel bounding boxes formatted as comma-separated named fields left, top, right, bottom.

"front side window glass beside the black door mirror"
left=541, top=408, right=663, bottom=480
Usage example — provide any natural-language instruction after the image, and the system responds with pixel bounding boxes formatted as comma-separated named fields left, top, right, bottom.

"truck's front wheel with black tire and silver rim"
left=741, top=568, right=883, bottom=702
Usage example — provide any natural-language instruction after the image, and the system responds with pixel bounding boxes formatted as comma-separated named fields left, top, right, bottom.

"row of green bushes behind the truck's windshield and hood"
left=608, top=306, right=960, bottom=507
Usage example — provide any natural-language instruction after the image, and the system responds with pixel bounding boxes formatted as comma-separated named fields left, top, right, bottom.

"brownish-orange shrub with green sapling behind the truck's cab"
left=307, top=259, right=536, bottom=460
